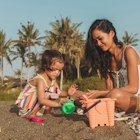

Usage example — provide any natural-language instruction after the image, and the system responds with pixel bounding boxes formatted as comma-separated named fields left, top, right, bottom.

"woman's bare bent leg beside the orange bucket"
left=107, top=89, right=139, bottom=113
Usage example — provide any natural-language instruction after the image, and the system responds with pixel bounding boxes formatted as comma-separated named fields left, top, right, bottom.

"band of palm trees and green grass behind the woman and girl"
left=0, top=17, right=139, bottom=101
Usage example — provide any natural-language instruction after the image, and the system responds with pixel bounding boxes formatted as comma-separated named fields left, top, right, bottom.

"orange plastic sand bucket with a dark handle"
left=82, top=98, right=116, bottom=128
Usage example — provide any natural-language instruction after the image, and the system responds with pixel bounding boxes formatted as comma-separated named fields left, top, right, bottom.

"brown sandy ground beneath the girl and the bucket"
left=0, top=102, right=136, bottom=140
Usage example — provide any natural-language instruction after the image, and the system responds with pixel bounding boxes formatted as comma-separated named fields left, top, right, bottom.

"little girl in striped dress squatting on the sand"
left=16, top=50, right=76, bottom=117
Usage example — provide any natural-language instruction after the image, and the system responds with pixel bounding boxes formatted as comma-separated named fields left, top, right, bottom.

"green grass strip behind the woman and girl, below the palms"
left=0, top=76, right=105, bottom=101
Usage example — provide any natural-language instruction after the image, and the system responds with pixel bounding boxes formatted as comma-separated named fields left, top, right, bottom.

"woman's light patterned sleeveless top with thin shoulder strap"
left=110, top=46, right=140, bottom=96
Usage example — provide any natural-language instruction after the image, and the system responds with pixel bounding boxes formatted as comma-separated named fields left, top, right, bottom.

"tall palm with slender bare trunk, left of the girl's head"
left=18, top=21, right=41, bottom=81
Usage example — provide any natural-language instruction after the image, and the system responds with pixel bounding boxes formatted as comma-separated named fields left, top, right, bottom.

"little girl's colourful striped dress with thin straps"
left=16, top=74, right=61, bottom=117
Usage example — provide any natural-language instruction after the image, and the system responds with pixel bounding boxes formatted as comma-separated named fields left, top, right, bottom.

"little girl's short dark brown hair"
left=40, top=50, right=64, bottom=71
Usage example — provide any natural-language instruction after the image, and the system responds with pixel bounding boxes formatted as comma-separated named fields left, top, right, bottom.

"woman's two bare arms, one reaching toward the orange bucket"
left=87, top=47, right=139, bottom=98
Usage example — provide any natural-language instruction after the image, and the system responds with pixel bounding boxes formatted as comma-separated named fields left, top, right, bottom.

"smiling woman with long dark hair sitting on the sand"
left=85, top=19, right=140, bottom=112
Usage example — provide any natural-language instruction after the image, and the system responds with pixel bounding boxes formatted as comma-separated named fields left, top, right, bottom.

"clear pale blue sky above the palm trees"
left=0, top=0, right=140, bottom=76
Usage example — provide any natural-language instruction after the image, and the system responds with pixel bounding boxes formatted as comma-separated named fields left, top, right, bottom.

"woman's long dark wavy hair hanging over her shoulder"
left=85, top=19, right=122, bottom=77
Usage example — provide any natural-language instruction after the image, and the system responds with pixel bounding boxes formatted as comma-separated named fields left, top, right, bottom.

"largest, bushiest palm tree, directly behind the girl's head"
left=45, top=17, right=84, bottom=88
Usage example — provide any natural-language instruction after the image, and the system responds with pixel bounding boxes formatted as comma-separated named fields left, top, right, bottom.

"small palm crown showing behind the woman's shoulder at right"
left=122, top=31, right=139, bottom=46
